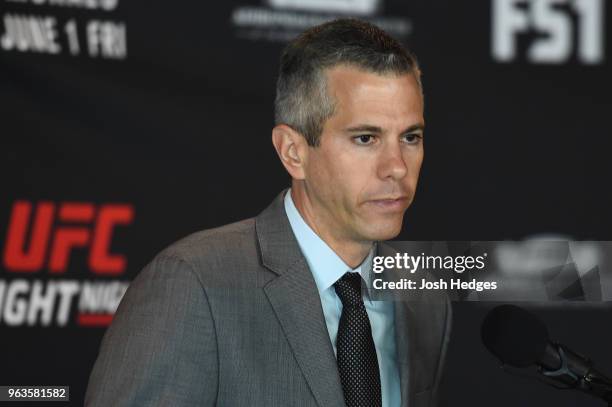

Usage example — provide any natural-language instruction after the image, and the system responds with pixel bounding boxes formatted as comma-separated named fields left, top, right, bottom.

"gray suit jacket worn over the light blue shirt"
left=85, top=194, right=451, bottom=407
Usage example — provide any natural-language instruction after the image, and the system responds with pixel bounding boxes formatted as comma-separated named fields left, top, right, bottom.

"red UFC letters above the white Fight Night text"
left=4, top=201, right=134, bottom=275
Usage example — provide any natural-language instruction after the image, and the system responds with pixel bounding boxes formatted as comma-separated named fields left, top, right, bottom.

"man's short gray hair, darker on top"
left=274, top=18, right=421, bottom=147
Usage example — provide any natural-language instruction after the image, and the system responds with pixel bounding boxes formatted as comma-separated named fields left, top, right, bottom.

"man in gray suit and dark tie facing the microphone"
left=86, top=19, right=450, bottom=407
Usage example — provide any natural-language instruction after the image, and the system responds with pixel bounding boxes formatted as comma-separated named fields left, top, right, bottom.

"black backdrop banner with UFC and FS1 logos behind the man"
left=0, top=0, right=612, bottom=406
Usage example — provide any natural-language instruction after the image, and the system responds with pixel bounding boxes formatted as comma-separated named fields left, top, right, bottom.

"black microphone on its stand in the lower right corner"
left=480, top=305, right=612, bottom=405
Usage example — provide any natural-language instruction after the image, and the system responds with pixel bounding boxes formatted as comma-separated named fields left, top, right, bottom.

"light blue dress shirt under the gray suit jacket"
left=285, top=190, right=401, bottom=407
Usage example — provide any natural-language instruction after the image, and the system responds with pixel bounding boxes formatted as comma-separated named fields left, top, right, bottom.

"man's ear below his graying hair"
left=272, top=124, right=308, bottom=179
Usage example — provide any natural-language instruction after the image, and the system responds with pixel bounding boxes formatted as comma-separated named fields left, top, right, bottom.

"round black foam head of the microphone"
left=480, top=305, right=549, bottom=367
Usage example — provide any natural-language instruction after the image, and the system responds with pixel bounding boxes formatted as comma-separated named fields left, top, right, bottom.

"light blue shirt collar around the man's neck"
left=285, top=189, right=375, bottom=300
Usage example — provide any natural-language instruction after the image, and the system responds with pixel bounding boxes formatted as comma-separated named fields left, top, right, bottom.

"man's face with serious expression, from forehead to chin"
left=304, top=66, right=424, bottom=242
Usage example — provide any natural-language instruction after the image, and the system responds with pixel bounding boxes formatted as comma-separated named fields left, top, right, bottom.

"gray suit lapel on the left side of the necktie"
left=255, top=192, right=344, bottom=407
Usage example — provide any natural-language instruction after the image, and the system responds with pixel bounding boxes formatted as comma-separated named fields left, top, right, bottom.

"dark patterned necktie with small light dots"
left=334, top=273, right=382, bottom=407
